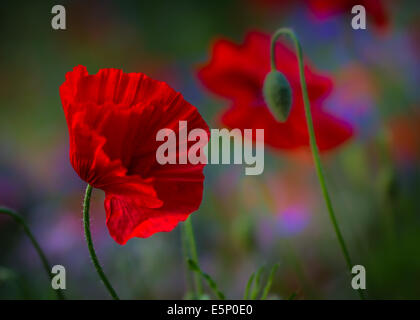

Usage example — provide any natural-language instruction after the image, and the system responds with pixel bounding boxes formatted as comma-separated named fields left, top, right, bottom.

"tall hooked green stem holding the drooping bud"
left=271, top=28, right=364, bottom=299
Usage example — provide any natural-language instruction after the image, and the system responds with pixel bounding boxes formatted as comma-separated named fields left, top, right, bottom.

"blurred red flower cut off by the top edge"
left=309, top=0, right=389, bottom=28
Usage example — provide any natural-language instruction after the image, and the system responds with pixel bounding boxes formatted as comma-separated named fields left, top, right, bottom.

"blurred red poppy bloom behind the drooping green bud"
left=198, top=32, right=353, bottom=151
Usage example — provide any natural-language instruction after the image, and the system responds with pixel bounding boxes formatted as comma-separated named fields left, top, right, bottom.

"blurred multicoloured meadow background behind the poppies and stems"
left=0, top=0, right=420, bottom=299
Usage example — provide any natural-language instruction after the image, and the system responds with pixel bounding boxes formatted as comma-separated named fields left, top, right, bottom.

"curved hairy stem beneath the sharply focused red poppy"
left=83, top=184, right=119, bottom=300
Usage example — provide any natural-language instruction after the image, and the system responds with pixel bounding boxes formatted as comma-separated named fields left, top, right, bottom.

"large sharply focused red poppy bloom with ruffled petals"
left=60, top=66, right=209, bottom=244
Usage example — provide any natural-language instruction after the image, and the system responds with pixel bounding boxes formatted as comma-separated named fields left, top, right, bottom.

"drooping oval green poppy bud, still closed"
left=263, top=70, right=292, bottom=122
